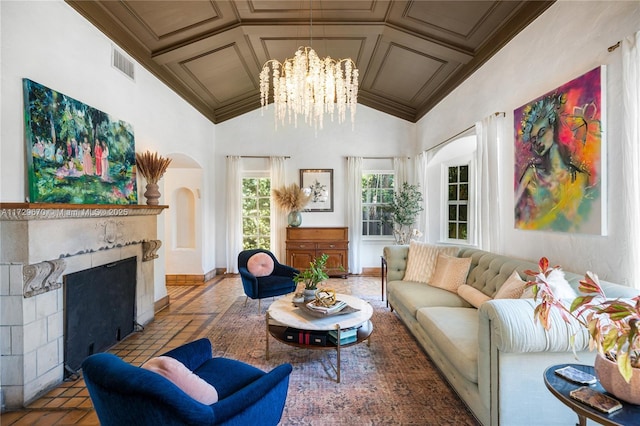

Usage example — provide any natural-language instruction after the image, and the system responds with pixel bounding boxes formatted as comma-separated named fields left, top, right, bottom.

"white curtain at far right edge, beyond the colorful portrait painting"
left=622, top=32, right=640, bottom=288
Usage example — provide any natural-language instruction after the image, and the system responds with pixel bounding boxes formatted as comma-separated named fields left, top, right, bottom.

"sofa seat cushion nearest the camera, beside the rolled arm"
left=416, top=307, right=478, bottom=383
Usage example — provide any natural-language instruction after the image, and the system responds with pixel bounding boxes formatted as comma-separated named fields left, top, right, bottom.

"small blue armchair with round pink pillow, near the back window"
left=238, top=249, right=299, bottom=309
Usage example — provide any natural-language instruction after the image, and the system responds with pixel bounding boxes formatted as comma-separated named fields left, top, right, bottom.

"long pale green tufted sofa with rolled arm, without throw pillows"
left=383, top=246, right=638, bottom=426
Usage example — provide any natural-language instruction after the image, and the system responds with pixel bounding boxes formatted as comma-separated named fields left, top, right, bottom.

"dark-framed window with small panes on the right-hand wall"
left=446, top=164, right=470, bottom=242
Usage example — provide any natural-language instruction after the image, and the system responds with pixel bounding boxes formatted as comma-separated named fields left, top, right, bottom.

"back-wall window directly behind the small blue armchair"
left=242, top=177, right=271, bottom=250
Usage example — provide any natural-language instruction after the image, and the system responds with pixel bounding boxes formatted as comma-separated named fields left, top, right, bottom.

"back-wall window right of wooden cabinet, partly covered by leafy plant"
left=362, top=171, right=394, bottom=237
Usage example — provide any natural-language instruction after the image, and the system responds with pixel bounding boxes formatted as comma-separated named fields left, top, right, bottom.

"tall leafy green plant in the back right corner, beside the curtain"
left=385, top=182, right=423, bottom=244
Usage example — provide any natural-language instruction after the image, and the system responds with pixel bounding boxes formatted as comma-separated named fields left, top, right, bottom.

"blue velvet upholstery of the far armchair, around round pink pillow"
left=238, top=249, right=299, bottom=299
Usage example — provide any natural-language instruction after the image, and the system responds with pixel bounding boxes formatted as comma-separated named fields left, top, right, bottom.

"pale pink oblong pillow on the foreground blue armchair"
left=142, top=356, right=218, bottom=405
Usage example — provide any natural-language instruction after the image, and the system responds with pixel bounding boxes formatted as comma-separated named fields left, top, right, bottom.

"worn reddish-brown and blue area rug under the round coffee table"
left=209, top=297, right=478, bottom=425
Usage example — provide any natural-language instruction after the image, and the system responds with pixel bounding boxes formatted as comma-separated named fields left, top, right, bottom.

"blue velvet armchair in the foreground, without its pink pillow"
left=82, top=339, right=292, bottom=426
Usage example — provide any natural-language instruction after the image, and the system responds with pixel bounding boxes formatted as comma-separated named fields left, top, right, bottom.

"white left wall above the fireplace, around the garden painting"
left=0, top=0, right=215, bottom=300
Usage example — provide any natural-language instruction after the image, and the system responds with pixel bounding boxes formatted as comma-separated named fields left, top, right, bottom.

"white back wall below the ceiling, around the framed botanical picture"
left=214, top=105, right=416, bottom=268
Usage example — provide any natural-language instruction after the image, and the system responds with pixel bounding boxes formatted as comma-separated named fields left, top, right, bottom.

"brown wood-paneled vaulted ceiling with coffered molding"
left=67, top=0, right=553, bottom=123
